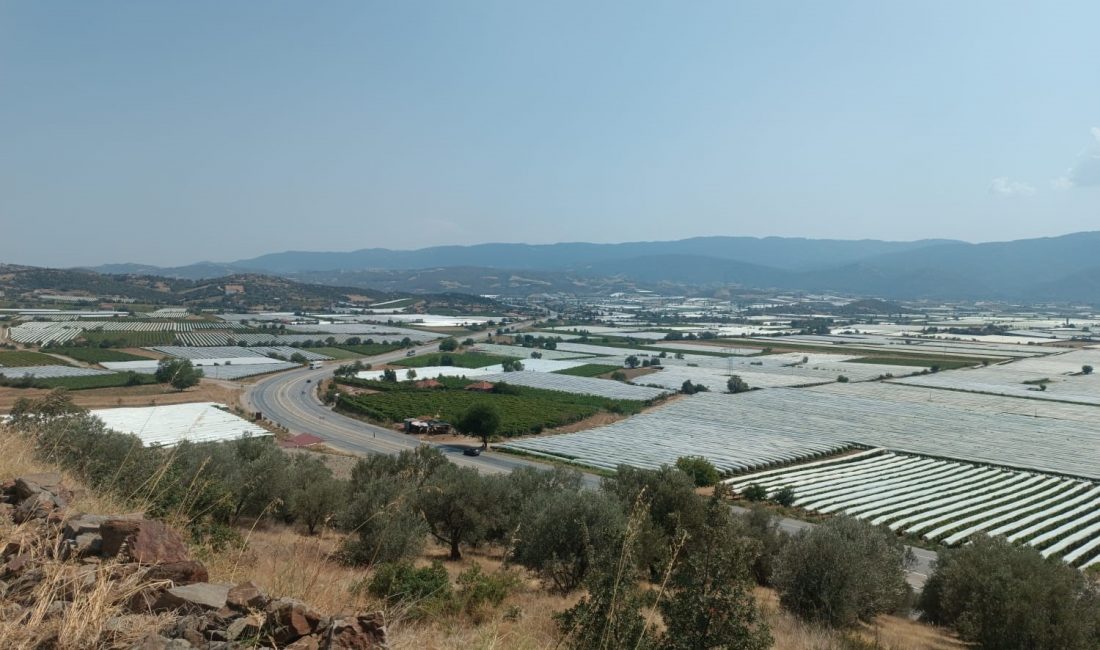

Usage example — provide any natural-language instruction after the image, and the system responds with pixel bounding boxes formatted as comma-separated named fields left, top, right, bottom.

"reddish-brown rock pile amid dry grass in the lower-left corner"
left=0, top=473, right=386, bottom=650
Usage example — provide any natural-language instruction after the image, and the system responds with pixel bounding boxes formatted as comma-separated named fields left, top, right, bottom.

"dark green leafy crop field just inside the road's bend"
left=339, top=380, right=644, bottom=437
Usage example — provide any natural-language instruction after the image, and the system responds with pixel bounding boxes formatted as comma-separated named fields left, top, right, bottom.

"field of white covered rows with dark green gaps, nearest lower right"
left=726, top=450, right=1100, bottom=568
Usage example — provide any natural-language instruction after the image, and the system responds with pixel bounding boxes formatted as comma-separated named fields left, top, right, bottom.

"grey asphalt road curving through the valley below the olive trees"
left=243, top=336, right=937, bottom=590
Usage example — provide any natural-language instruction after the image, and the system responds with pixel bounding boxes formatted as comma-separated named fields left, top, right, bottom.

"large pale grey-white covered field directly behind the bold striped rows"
left=503, top=380, right=1100, bottom=478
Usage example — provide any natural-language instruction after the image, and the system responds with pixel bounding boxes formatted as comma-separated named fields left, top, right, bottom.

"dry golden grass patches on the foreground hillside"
left=0, top=427, right=966, bottom=650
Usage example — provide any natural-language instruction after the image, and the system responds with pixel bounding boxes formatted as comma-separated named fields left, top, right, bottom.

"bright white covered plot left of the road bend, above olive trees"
left=91, top=401, right=271, bottom=445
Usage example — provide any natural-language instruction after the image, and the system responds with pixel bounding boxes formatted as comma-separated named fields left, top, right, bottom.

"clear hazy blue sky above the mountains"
left=0, top=0, right=1100, bottom=265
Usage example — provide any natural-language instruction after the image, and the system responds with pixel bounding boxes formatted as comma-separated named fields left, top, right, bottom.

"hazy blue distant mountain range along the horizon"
left=94, top=232, right=1100, bottom=305
